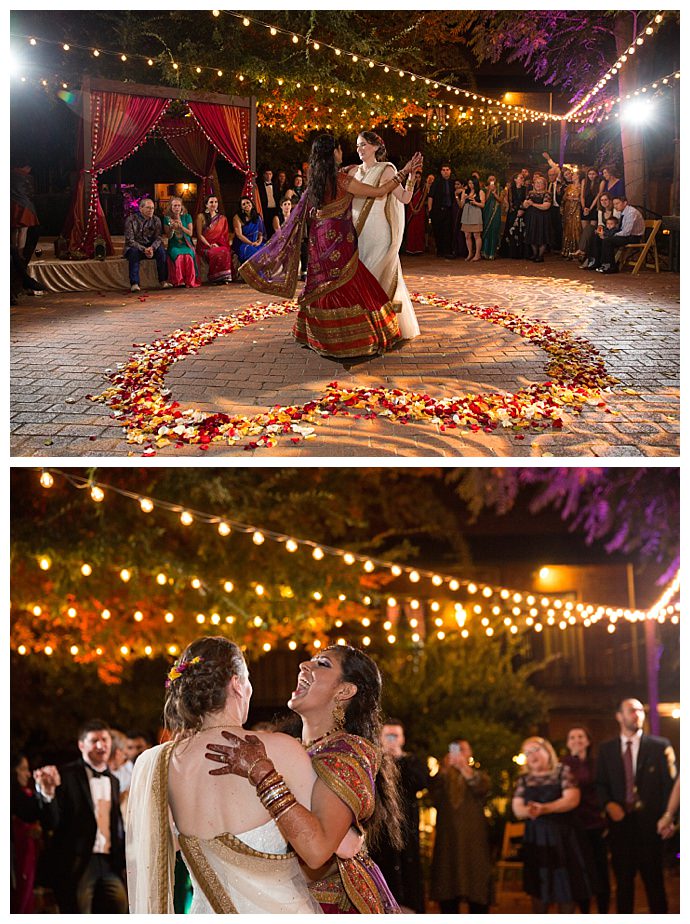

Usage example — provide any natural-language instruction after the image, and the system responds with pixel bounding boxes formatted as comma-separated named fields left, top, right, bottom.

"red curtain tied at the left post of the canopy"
left=68, top=91, right=170, bottom=257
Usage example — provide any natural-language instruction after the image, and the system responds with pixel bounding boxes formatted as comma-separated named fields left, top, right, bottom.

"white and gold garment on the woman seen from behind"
left=126, top=742, right=322, bottom=914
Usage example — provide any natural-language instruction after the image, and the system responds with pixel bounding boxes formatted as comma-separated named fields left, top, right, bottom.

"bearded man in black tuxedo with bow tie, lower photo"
left=41, top=719, right=127, bottom=914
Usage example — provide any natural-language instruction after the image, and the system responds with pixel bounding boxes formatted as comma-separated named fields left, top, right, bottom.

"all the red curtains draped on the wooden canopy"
left=63, top=90, right=254, bottom=257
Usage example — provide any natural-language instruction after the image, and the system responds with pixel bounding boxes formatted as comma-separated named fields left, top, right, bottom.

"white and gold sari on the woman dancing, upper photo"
left=351, top=162, right=419, bottom=340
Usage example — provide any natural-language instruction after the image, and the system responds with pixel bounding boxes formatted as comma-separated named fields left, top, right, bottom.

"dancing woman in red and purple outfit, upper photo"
left=240, top=135, right=421, bottom=359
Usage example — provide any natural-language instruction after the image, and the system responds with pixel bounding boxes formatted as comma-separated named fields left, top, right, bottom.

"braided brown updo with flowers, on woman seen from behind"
left=163, top=635, right=247, bottom=736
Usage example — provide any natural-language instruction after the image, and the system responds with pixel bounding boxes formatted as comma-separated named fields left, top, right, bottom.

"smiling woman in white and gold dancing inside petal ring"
left=348, top=132, right=419, bottom=340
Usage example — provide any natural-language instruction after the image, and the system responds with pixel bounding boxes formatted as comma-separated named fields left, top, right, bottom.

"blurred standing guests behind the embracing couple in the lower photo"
left=10, top=698, right=680, bottom=914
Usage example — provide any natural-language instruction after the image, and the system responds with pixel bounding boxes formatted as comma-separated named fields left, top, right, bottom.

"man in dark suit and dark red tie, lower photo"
left=597, top=699, right=676, bottom=914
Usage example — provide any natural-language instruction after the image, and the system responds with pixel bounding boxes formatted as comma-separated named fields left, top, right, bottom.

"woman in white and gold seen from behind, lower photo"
left=126, top=637, right=360, bottom=914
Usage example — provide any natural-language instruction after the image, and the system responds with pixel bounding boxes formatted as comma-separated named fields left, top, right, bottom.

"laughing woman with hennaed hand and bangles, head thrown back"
left=206, top=645, right=401, bottom=914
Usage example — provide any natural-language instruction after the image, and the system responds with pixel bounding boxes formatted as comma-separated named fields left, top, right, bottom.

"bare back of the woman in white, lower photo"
left=168, top=727, right=316, bottom=839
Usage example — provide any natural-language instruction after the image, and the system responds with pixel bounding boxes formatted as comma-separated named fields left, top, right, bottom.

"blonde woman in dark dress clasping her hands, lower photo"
left=512, top=738, right=592, bottom=914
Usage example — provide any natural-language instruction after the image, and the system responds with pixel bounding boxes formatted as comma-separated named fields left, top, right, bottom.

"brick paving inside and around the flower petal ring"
left=10, top=256, right=680, bottom=461
